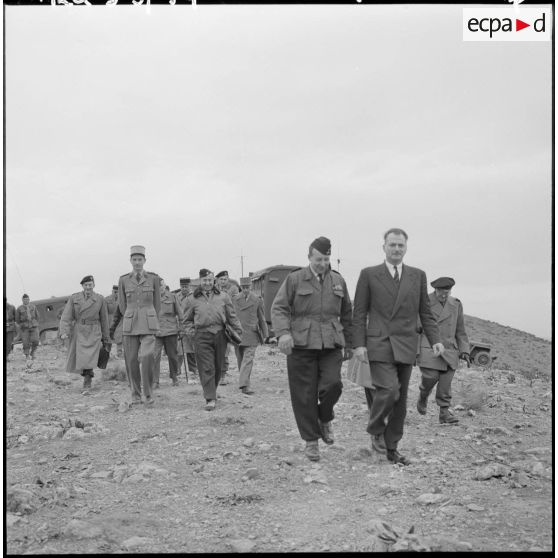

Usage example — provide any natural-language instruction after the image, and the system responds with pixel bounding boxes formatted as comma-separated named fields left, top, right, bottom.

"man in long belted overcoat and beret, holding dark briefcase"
left=59, top=275, right=109, bottom=389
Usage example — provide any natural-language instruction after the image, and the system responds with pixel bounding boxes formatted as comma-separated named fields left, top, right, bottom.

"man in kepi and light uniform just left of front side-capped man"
left=232, top=277, right=268, bottom=395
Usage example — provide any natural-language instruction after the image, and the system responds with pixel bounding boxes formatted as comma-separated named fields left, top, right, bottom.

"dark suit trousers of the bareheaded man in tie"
left=366, top=360, right=413, bottom=456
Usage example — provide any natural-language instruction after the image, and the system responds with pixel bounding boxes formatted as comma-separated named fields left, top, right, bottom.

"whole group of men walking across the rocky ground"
left=6, top=228, right=470, bottom=465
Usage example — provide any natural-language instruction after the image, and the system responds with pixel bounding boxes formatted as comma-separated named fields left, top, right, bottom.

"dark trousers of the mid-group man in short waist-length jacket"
left=194, top=330, right=227, bottom=401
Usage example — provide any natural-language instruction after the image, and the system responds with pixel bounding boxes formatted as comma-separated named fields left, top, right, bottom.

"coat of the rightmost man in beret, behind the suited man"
left=417, top=293, right=469, bottom=370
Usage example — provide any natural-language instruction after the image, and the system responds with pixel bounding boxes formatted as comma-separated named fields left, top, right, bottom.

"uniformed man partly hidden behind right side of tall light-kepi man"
left=153, top=278, right=184, bottom=388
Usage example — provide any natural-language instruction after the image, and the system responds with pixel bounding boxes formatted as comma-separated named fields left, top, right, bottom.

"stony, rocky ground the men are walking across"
left=5, top=345, right=553, bottom=554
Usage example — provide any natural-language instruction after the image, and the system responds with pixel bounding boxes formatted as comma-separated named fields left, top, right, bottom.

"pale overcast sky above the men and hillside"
left=4, top=4, right=553, bottom=338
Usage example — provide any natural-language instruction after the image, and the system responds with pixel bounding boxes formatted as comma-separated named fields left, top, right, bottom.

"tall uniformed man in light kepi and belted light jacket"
left=115, top=246, right=161, bottom=406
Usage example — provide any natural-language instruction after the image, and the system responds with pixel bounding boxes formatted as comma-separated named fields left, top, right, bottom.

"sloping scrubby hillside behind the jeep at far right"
left=465, top=315, right=552, bottom=379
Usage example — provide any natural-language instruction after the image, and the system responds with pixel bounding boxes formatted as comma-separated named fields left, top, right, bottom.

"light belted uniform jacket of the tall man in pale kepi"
left=118, top=271, right=161, bottom=335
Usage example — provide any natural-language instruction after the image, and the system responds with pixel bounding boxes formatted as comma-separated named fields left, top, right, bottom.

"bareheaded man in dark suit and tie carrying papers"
left=353, top=229, right=444, bottom=465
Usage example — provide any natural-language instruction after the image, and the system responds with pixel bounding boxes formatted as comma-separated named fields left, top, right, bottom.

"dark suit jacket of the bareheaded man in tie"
left=353, top=263, right=440, bottom=364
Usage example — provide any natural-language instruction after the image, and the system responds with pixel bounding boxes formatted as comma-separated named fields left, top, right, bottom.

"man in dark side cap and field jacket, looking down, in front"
left=271, top=236, right=352, bottom=461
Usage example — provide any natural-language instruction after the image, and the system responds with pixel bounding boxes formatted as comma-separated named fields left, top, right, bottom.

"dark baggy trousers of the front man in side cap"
left=287, top=349, right=343, bottom=441
